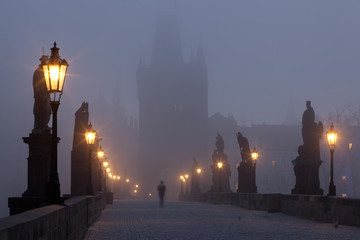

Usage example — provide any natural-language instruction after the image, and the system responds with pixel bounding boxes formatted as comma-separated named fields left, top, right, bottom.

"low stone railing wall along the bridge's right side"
left=179, top=192, right=360, bottom=226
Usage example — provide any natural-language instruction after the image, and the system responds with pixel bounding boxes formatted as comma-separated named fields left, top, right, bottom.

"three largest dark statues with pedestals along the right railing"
left=205, top=101, right=323, bottom=195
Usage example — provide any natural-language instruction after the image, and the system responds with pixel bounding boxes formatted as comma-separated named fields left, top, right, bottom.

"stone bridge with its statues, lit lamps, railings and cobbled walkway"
left=0, top=43, right=360, bottom=240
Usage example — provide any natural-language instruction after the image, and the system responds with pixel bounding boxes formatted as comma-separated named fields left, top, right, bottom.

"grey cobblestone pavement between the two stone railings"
left=85, top=200, right=360, bottom=240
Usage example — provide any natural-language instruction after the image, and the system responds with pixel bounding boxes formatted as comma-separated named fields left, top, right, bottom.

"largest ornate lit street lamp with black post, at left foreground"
left=42, top=42, right=69, bottom=204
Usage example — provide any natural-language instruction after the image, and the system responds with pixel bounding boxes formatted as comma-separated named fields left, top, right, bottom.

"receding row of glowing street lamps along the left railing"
left=21, top=42, right=139, bottom=204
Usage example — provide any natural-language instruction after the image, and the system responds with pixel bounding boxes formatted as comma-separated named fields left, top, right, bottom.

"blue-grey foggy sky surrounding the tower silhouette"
left=0, top=0, right=360, bottom=216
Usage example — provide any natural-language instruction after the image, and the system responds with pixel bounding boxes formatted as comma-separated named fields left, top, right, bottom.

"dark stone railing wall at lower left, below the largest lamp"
left=0, top=193, right=112, bottom=240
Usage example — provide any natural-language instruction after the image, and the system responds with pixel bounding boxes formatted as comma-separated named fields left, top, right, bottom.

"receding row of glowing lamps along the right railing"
left=179, top=123, right=338, bottom=196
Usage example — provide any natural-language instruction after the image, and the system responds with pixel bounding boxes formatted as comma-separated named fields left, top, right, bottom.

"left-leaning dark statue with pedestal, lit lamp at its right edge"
left=236, top=132, right=257, bottom=193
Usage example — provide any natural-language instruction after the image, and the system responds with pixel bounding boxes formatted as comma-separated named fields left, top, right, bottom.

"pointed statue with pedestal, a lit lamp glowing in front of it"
left=210, top=133, right=231, bottom=192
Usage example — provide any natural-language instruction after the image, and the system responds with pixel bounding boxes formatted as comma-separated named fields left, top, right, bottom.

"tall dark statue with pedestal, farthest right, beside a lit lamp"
left=291, top=101, right=323, bottom=195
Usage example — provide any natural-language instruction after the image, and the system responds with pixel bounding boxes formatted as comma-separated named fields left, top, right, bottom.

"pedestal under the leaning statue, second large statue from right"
left=237, top=162, right=257, bottom=193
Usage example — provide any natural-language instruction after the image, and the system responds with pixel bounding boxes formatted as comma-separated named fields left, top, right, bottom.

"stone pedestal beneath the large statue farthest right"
left=291, top=160, right=324, bottom=195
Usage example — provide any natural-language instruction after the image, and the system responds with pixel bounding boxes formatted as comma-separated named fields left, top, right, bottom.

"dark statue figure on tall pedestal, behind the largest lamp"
left=33, top=55, right=51, bottom=133
